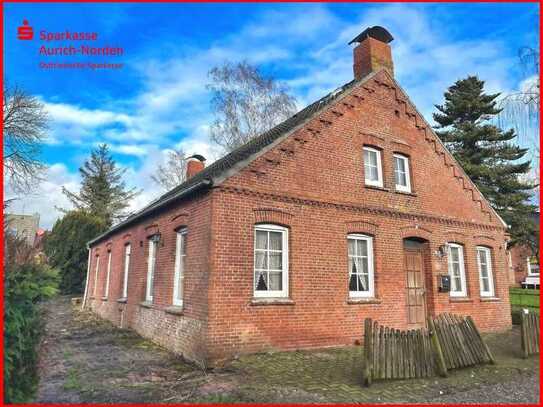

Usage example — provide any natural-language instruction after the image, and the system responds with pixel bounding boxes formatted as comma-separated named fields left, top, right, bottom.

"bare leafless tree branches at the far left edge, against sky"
left=3, top=86, right=48, bottom=192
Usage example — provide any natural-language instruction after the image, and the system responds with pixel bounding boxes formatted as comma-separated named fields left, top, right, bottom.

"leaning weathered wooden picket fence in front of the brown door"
left=363, top=314, right=494, bottom=386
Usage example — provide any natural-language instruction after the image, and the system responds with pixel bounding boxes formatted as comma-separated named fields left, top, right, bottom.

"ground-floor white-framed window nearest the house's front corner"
left=254, top=225, right=288, bottom=297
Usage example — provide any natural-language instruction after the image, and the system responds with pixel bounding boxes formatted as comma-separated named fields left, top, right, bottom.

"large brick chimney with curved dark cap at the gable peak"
left=349, top=25, right=394, bottom=79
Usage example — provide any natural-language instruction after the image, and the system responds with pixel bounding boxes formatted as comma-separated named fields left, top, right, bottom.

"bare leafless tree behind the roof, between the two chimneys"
left=208, top=61, right=296, bottom=151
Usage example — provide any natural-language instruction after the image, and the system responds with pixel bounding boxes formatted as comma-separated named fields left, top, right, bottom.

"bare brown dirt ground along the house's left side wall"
left=36, top=297, right=235, bottom=403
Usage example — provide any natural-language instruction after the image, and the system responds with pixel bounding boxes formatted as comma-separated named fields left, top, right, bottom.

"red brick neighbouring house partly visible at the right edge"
left=509, top=213, right=539, bottom=289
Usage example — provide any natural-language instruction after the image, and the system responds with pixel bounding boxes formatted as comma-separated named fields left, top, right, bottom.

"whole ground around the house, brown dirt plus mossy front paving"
left=36, top=297, right=539, bottom=403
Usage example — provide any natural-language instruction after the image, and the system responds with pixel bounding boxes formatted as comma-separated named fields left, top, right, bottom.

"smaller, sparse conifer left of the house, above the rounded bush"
left=62, top=144, right=140, bottom=227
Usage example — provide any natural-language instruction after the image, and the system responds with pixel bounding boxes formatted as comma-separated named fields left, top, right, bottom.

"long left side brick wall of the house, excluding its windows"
left=88, top=194, right=211, bottom=362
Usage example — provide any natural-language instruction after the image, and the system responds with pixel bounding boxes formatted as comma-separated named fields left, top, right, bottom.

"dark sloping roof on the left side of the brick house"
left=88, top=78, right=362, bottom=245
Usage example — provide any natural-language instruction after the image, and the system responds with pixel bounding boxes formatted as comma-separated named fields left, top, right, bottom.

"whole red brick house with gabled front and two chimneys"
left=86, top=27, right=511, bottom=361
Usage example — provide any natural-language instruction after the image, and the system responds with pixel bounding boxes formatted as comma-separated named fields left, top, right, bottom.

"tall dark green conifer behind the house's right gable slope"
left=433, top=76, right=539, bottom=246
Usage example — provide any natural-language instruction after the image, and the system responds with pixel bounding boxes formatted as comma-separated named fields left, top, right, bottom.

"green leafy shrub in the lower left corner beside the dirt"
left=4, top=263, right=58, bottom=403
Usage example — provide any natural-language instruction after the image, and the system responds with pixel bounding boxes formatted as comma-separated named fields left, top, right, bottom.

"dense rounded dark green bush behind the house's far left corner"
left=44, top=210, right=107, bottom=294
